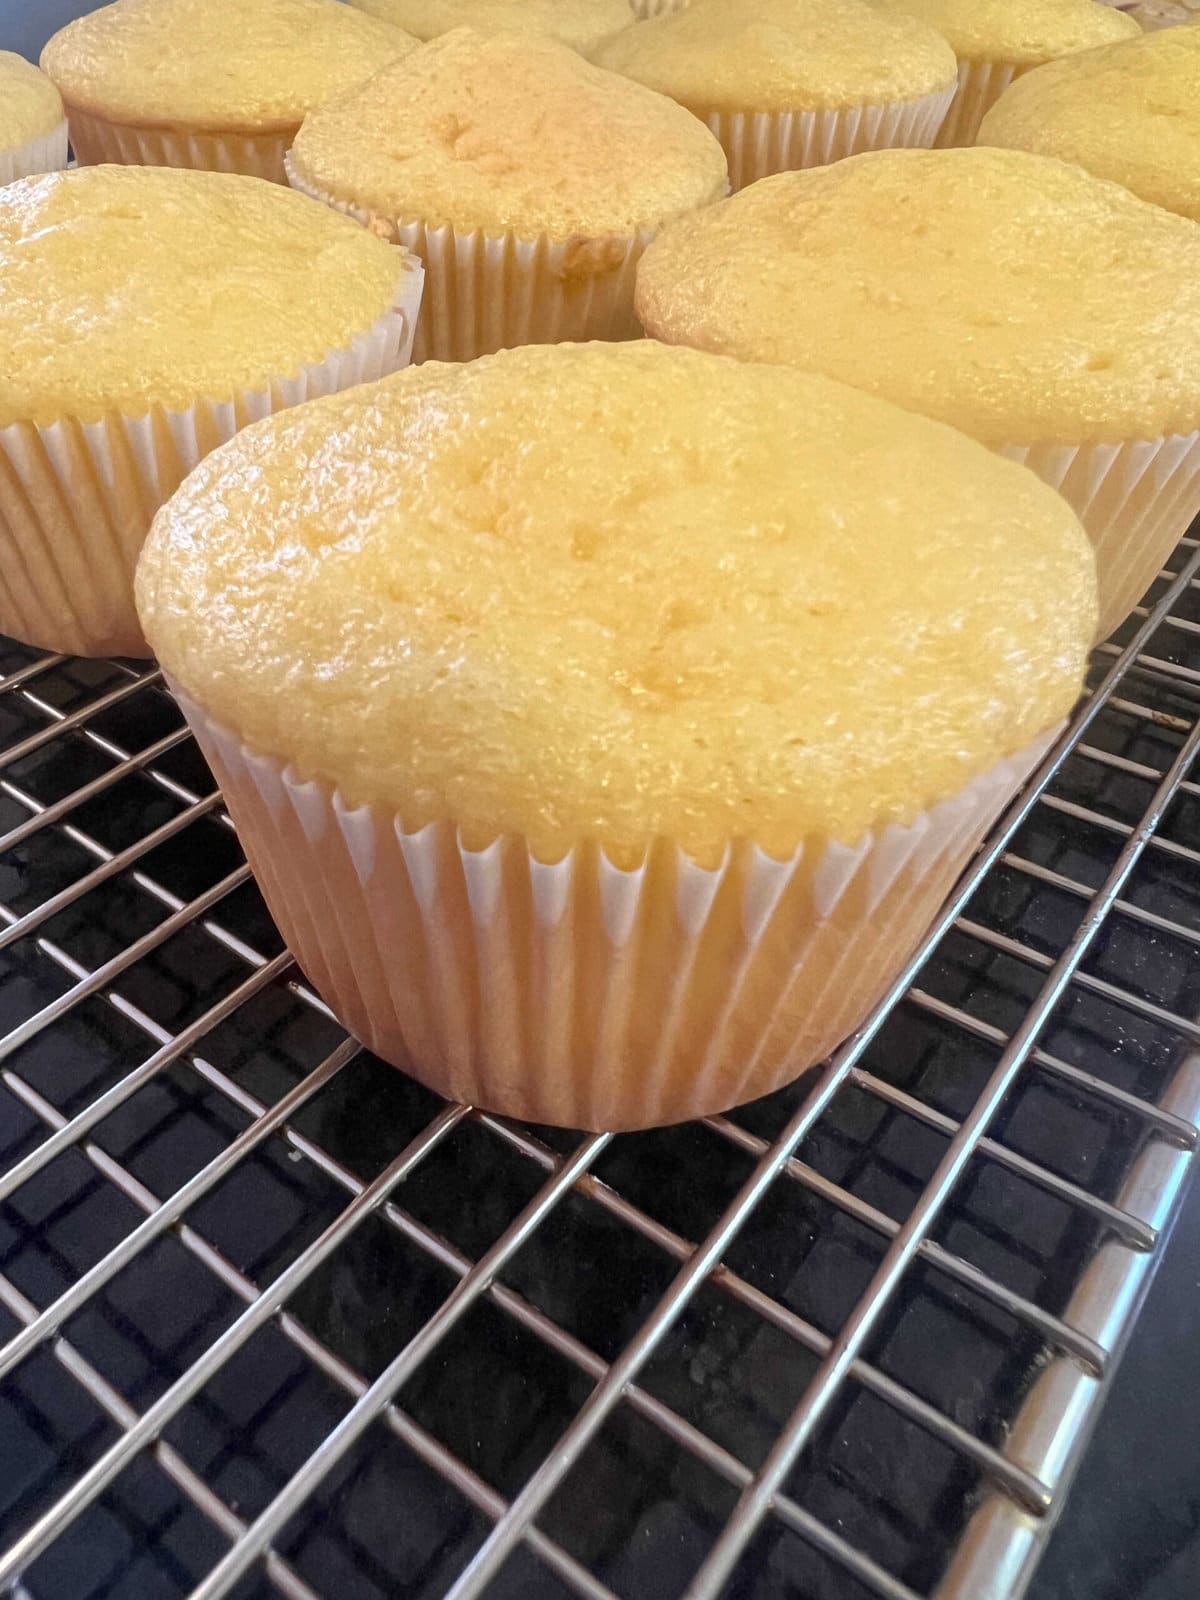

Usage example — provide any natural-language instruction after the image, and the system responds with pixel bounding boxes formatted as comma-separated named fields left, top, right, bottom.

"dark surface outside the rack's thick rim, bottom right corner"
left=1027, top=1174, right=1200, bottom=1600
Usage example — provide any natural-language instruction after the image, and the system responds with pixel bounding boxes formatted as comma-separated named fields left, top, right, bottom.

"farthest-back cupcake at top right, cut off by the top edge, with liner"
left=874, top=0, right=1141, bottom=146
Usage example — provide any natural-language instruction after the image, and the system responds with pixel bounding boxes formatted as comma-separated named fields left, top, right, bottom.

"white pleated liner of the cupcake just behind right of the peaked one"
left=704, top=83, right=955, bottom=190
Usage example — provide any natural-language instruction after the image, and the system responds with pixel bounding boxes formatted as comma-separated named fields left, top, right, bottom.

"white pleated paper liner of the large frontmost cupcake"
left=176, top=690, right=1054, bottom=1128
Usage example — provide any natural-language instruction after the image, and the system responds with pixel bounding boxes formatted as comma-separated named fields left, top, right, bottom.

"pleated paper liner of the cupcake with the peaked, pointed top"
left=286, top=158, right=654, bottom=362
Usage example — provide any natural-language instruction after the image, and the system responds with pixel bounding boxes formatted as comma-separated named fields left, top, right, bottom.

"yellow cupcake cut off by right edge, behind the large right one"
left=979, top=27, right=1200, bottom=222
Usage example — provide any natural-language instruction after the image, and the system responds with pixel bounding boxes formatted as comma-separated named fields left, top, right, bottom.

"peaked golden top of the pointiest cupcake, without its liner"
left=290, top=27, right=726, bottom=240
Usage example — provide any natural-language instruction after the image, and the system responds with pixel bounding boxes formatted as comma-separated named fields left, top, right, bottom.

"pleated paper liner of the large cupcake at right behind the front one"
left=998, top=432, right=1200, bottom=638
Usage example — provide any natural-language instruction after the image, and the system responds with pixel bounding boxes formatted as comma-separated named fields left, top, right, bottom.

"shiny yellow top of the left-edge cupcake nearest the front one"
left=0, top=166, right=411, bottom=426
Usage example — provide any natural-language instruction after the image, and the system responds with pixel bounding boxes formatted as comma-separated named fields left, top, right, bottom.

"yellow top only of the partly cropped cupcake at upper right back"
left=872, top=0, right=1141, bottom=66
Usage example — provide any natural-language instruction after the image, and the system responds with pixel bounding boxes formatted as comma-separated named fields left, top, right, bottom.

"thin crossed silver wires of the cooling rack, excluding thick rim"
left=0, top=541, right=1200, bottom=1600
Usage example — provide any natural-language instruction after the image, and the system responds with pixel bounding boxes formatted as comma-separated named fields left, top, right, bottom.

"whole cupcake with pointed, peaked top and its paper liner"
left=288, top=27, right=726, bottom=362
